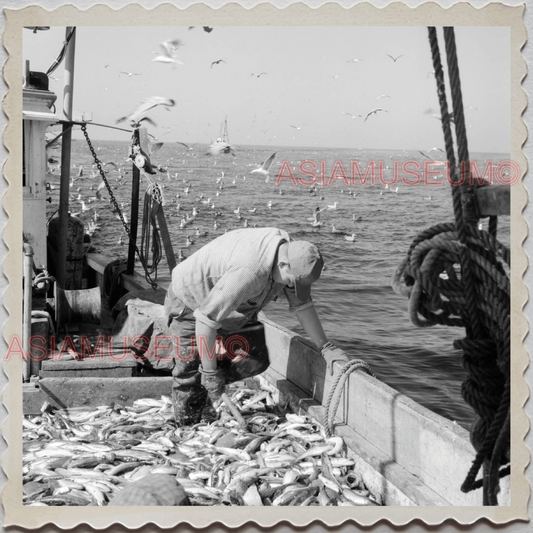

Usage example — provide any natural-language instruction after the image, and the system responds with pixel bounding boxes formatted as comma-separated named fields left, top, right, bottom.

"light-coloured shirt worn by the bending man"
left=171, top=228, right=313, bottom=331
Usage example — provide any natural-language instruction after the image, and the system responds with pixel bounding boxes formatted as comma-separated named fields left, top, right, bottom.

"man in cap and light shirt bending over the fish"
left=165, top=228, right=349, bottom=425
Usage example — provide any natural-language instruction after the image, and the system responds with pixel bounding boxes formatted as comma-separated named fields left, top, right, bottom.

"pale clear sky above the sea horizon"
left=23, top=26, right=510, bottom=153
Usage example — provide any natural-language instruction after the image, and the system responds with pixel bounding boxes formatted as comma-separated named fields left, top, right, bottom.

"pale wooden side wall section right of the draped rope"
left=340, top=373, right=481, bottom=505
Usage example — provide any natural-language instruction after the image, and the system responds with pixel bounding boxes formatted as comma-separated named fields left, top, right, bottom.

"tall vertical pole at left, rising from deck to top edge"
left=56, top=26, right=76, bottom=289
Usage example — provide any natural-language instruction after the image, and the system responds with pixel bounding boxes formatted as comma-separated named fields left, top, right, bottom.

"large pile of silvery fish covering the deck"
left=23, top=387, right=380, bottom=506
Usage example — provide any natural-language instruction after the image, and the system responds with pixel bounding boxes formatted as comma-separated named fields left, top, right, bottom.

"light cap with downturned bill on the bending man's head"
left=287, top=241, right=324, bottom=302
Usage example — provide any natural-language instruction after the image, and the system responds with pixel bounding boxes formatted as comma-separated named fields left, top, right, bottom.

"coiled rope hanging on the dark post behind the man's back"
left=140, top=183, right=163, bottom=279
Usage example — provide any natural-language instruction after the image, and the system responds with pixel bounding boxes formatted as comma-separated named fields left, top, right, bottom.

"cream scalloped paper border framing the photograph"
left=2, top=2, right=530, bottom=529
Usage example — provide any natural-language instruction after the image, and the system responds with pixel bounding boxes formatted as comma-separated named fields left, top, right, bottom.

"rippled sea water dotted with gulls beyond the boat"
left=43, top=140, right=510, bottom=428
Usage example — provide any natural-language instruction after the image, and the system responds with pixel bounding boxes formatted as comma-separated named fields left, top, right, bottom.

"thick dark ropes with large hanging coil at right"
left=392, top=28, right=511, bottom=505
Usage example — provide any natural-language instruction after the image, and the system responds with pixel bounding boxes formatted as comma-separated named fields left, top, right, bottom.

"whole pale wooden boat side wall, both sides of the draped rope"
left=260, top=315, right=510, bottom=505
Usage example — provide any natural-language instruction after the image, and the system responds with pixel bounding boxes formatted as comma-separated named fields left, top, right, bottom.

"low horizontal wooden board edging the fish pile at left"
left=22, top=377, right=172, bottom=415
